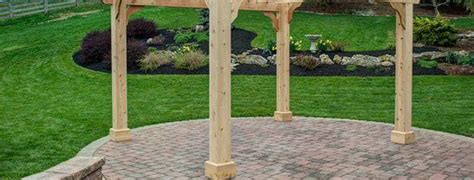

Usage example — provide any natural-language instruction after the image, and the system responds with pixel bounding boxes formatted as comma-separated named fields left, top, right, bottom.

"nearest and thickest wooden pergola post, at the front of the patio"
left=205, top=0, right=240, bottom=179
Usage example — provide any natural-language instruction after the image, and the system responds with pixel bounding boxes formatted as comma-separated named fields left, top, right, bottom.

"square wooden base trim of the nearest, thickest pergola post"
left=204, top=161, right=237, bottom=179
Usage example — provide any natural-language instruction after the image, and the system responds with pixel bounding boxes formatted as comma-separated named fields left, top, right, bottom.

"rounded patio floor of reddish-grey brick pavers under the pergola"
left=90, top=117, right=474, bottom=179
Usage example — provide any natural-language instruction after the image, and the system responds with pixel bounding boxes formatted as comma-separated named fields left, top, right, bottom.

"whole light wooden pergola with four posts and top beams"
left=103, top=0, right=419, bottom=179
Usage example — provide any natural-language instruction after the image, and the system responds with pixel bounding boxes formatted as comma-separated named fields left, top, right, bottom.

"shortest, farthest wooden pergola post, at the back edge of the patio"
left=274, top=4, right=293, bottom=121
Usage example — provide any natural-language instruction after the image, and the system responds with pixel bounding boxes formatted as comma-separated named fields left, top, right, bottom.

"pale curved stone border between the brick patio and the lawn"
left=77, top=116, right=474, bottom=157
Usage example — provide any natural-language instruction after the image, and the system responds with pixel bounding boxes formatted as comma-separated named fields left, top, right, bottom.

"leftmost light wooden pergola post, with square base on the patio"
left=110, top=0, right=132, bottom=141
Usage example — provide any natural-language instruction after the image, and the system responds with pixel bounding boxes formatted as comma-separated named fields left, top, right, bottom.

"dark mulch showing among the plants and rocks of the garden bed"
left=73, top=28, right=445, bottom=76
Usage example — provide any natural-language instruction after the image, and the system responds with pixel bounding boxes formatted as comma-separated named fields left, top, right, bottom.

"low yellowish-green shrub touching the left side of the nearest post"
left=175, top=50, right=209, bottom=70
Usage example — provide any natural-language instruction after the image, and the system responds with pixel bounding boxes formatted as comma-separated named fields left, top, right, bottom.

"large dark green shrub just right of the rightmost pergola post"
left=413, top=17, right=458, bottom=46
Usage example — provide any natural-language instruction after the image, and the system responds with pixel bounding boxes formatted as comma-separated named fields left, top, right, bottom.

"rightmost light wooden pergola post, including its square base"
left=391, top=2, right=415, bottom=144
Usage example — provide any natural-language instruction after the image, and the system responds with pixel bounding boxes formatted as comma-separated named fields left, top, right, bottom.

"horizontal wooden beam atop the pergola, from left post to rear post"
left=102, top=0, right=296, bottom=11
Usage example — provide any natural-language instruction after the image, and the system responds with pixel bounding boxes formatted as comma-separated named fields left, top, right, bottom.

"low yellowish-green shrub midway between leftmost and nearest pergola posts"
left=138, top=51, right=175, bottom=71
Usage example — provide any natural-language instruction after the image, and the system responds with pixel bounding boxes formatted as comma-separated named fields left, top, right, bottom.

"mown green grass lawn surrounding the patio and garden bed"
left=0, top=3, right=474, bottom=179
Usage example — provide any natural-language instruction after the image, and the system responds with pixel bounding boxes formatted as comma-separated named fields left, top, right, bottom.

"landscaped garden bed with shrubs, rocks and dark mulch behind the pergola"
left=73, top=15, right=474, bottom=76
